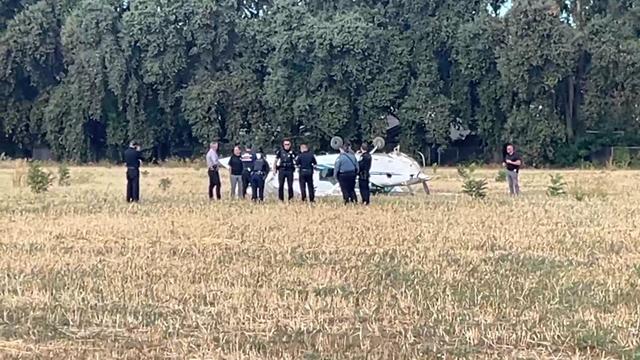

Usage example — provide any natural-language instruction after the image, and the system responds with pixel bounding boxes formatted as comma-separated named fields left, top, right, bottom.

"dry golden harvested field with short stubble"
left=0, top=164, right=640, bottom=359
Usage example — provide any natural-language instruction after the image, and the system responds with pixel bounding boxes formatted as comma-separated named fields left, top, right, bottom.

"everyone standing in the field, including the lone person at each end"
left=124, top=139, right=522, bottom=205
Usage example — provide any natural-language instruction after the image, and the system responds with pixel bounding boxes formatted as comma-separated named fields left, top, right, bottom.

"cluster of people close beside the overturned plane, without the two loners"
left=206, top=139, right=372, bottom=205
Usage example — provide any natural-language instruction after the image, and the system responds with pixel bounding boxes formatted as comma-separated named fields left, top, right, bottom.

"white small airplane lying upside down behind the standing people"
left=220, top=137, right=430, bottom=197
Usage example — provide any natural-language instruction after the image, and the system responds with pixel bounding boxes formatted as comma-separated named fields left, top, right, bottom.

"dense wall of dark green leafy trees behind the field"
left=0, top=0, right=640, bottom=164
